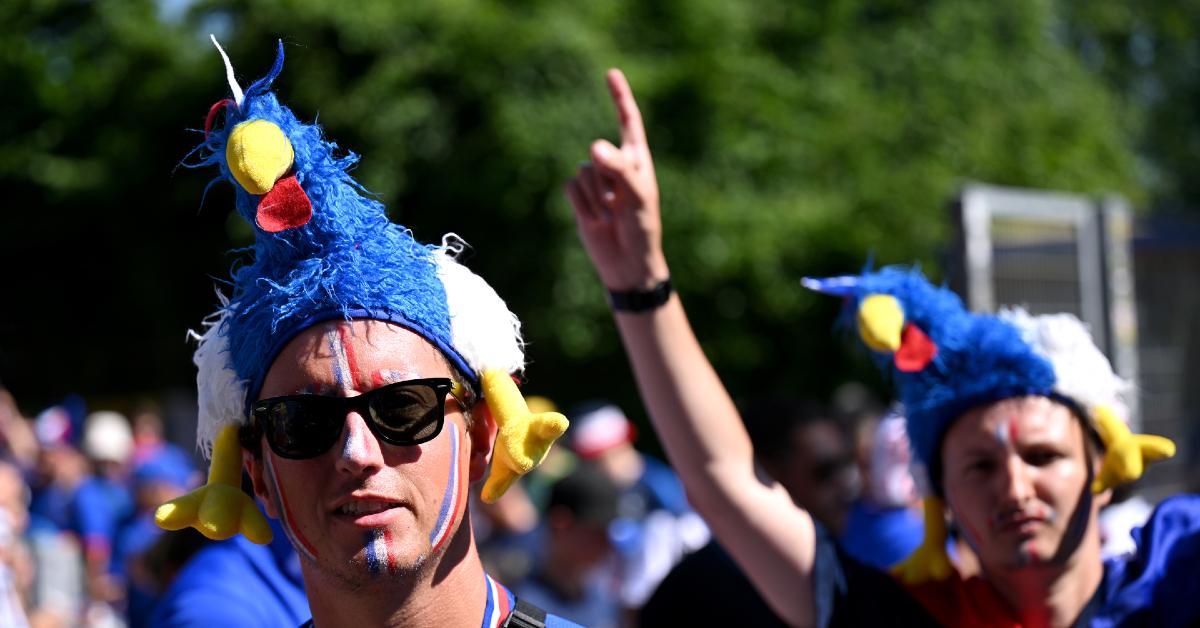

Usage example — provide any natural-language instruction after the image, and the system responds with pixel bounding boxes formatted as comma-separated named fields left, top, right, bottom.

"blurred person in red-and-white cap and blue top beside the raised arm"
left=566, top=401, right=709, bottom=614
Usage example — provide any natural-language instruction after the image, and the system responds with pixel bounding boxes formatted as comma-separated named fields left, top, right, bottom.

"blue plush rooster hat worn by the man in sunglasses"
left=157, top=38, right=566, bottom=543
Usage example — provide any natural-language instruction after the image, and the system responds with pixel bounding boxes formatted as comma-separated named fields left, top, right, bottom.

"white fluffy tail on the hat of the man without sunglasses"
left=1000, top=309, right=1132, bottom=423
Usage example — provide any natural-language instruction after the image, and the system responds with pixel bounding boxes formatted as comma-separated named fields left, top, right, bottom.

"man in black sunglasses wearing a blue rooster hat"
left=156, top=40, right=570, bottom=628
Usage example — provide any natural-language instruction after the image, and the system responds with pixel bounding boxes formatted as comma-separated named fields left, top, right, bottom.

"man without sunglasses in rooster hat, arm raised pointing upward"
left=566, top=71, right=1200, bottom=627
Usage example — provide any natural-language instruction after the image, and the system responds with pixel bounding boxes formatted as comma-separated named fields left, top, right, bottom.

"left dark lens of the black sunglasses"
left=263, top=395, right=342, bottom=459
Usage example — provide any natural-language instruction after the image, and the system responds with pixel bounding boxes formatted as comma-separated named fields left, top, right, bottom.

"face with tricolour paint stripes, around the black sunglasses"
left=250, top=321, right=490, bottom=582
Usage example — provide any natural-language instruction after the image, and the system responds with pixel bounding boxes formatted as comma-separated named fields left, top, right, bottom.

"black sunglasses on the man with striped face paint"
left=242, top=377, right=466, bottom=460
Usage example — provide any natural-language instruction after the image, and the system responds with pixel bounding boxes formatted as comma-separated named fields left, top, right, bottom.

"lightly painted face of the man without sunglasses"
left=942, top=397, right=1099, bottom=569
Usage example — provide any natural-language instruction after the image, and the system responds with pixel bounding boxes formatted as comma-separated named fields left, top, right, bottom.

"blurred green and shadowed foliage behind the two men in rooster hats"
left=0, top=0, right=1200, bottom=437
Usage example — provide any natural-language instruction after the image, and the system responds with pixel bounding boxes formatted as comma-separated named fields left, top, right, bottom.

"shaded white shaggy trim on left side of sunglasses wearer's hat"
left=188, top=291, right=246, bottom=460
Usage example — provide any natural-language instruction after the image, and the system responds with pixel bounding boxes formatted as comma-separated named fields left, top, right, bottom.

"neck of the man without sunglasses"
left=985, top=516, right=1104, bottom=628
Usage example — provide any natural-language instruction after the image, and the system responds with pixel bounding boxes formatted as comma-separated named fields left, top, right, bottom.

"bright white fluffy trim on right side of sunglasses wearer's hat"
left=434, top=233, right=524, bottom=373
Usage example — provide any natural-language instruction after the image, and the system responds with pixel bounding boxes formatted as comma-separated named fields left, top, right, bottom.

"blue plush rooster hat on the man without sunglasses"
left=804, top=267, right=1175, bottom=581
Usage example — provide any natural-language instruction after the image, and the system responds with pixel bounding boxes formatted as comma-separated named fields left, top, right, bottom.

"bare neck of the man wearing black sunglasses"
left=302, top=516, right=487, bottom=628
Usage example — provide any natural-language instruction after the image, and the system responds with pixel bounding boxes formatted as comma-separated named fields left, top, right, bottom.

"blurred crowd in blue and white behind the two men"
left=0, top=385, right=1150, bottom=628
